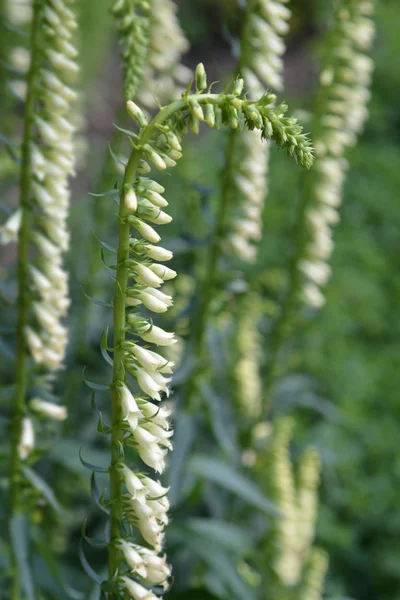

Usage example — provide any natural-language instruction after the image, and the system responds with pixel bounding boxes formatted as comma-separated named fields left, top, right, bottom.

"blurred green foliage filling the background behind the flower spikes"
left=0, top=0, right=400, bottom=600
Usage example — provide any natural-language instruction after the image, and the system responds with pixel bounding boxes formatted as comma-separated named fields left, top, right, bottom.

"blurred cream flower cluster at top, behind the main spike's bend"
left=137, top=0, right=192, bottom=110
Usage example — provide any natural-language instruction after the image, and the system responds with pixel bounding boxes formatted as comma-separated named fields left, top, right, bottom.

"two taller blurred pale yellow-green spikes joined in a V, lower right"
left=268, top=418, right=321, bottom=587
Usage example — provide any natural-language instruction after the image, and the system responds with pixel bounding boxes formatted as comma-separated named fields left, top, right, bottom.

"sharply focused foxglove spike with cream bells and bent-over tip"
left=86, top=64, right=313, bottom=600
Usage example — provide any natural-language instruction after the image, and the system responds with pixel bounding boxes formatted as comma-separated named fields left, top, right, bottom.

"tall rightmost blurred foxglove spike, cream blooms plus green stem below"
left=265, top=0, right=374, bottom=389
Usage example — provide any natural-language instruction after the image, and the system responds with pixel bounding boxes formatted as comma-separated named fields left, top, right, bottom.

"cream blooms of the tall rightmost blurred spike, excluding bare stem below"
left=299, top=0, right=374, bottom=308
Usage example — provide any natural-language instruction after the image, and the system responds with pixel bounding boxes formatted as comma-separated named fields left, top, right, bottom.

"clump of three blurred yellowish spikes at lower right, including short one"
left=260, top=418, right=327, bottom=600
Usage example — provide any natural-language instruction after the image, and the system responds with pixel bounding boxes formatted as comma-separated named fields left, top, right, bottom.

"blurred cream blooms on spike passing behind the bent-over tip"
left=227, top=0, right=291, bottom=262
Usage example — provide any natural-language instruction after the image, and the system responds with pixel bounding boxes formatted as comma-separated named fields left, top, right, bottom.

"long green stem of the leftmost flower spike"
left=10, top=0, right=42, bottom=600
